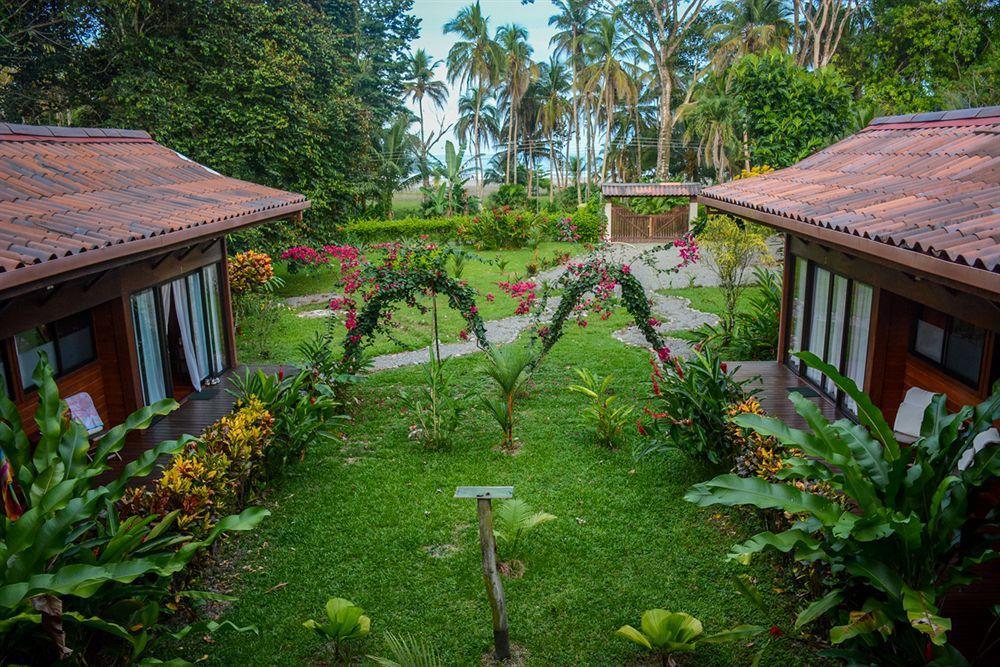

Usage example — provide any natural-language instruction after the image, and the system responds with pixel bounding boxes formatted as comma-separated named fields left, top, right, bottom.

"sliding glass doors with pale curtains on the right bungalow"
left=788, top=257, right=872, bottom=413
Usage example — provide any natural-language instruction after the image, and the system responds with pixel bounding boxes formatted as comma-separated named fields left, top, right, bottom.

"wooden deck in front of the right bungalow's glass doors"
left=726, top=361, right=847, bottom=429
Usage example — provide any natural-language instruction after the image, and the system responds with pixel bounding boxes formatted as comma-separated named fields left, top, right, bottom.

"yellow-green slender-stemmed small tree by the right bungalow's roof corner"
left=698, top=215, right=773, bottom=333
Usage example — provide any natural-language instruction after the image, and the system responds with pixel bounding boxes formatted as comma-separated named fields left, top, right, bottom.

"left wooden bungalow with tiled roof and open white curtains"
left=0, top=123, right=309, bottom=454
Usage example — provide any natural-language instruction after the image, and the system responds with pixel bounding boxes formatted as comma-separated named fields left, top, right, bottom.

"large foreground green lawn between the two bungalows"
left=178, top=306, right=808, bottom=665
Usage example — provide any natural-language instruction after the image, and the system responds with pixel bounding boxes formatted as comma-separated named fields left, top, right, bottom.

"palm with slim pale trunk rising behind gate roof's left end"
left=583, top=16, right=636, bottom=187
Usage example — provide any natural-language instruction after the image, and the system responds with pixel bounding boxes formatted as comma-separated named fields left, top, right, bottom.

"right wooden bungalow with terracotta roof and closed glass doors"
left=698, top=107, right=1000, bottom=430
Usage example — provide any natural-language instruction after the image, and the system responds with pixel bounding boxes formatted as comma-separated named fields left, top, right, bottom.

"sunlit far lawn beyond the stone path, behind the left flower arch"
left=237, top=243, right=582, bottom=364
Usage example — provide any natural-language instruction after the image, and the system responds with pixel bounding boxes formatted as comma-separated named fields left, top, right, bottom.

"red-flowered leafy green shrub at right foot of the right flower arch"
left=636, top=350, right=747, bottom=465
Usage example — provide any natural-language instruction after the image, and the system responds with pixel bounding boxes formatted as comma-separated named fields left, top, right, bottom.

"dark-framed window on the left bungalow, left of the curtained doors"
left=14, top=311, right=97, bottom=389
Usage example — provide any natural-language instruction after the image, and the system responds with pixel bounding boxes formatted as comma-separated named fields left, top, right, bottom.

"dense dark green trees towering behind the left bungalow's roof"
left=0, top=0, right=416, bottom=249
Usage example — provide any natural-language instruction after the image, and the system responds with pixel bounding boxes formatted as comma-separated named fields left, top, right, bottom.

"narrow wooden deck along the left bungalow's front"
left=112, top=366, right=292, bottom=477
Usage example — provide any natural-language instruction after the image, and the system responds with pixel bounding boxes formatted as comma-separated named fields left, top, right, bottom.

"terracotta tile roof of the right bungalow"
left=698, top=107, right=1000, bottom=282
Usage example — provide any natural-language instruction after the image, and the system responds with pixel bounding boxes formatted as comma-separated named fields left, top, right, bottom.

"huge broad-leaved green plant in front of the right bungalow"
left=685, top=352, right=1000, bottom=665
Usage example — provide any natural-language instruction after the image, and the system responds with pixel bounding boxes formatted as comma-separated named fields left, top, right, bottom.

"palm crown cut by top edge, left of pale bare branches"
left=708, top=0, right=792, bottom=70
